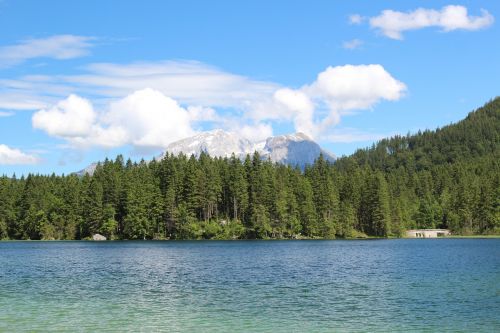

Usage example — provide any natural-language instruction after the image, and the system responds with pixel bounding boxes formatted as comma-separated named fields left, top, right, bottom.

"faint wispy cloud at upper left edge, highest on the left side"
left=0, top=35, right=94, bottom=68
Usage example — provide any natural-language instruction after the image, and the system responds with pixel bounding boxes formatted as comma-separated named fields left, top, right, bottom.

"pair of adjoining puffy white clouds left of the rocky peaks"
left=32, top=88, right=194, bottom=148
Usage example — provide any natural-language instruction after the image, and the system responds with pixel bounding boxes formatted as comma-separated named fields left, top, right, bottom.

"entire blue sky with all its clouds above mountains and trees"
left=0, top=0, right=500, bottom=175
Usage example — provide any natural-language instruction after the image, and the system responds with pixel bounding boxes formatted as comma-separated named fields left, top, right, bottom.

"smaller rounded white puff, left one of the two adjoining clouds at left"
left=32, top=95, right=96, bottom=138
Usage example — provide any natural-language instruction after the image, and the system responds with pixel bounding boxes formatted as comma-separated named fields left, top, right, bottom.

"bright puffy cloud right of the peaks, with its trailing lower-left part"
left=253, top=65, right=406, bottom=138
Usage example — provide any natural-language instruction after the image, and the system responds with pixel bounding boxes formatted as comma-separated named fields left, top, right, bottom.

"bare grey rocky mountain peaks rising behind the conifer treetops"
left=165, top=129, right=335, bottom=168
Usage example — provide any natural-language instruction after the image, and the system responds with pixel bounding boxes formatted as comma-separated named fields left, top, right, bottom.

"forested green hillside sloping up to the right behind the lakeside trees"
left=336, top=97, right=500, bottom=172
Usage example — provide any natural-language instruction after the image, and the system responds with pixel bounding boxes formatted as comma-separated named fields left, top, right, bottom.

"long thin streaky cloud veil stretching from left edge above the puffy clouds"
left=0, top=61, right=281, bottom=111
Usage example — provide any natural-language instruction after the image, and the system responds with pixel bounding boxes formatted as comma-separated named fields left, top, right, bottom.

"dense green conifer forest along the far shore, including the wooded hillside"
left=0, top=98, right=500, bottom=239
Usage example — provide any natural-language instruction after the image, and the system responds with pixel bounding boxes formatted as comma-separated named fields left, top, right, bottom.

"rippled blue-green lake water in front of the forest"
left=0, top=239, right=500, bottom=332
